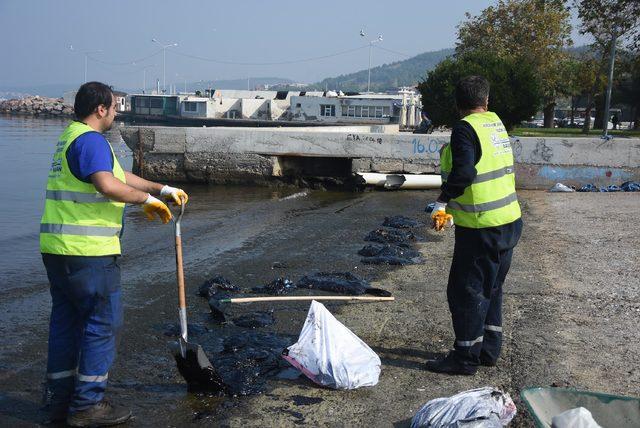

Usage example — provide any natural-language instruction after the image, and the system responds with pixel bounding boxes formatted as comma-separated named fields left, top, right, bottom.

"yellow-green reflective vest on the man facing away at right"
left=440, top=112, right=521, bottom=229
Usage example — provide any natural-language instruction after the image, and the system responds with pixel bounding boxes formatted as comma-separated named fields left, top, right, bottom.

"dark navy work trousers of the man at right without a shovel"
left=447, top=219, right=522, bottom=366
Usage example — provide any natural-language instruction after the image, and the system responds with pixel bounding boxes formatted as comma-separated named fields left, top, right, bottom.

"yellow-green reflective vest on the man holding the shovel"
left=40, top=122, right=126, bottom=256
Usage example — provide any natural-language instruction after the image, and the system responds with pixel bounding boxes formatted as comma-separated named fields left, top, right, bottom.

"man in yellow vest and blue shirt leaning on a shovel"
left=40, top=82, right=188, bottom=426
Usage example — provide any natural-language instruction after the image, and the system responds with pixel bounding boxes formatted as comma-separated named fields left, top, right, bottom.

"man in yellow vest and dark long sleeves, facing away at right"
left=427, top=76, right=522, bottom=375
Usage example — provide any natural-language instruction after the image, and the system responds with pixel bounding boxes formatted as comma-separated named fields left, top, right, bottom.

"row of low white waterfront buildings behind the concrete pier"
left=129, top=88, right=421, bottom=129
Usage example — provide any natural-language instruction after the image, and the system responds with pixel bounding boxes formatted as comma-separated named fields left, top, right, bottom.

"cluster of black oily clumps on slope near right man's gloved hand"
left=358, top=215, right=424, bottom=266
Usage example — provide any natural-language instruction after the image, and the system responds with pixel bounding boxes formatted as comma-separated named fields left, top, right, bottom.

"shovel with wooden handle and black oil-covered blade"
left=169, top=202, right=225, bottom=393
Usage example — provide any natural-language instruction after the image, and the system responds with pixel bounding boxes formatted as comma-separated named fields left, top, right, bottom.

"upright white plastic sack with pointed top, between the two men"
left=283, top=300, right=381, bottom=389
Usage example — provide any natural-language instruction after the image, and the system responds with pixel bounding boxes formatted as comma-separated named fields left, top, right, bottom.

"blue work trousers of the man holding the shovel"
left=42, top=254, right=123, bottom=412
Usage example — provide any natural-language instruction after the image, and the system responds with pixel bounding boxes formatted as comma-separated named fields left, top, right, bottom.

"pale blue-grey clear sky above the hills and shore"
left=0, top=0, right=586, bottom=88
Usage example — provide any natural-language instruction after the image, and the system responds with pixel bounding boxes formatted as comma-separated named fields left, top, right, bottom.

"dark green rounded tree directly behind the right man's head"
left=418, top=53, right=541, bottom=129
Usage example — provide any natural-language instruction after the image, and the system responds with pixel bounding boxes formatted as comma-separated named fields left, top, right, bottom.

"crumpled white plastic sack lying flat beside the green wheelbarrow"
left=411, top=387, right=516, bottom=428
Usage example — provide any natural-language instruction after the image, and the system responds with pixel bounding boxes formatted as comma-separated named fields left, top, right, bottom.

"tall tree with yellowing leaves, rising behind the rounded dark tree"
left=456, top=0, right=572, bottom=127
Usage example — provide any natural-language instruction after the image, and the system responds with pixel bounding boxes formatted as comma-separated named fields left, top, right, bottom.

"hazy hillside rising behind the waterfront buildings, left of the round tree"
left=311, top=49, right=454, bottom=91
